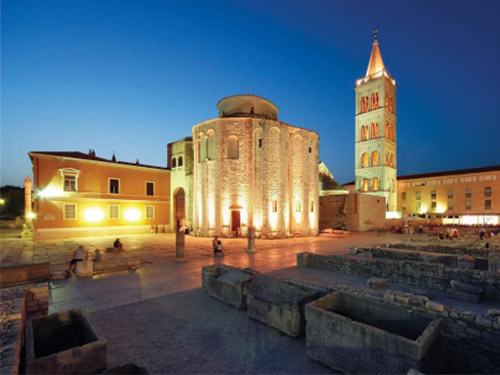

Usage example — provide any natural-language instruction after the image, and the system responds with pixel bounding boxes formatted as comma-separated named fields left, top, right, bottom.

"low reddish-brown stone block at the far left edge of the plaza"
left=0, top=262, right=50, bottom=288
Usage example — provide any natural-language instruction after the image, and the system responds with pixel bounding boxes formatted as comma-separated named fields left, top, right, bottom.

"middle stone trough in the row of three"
left=245, top=274, right=324, bottom=337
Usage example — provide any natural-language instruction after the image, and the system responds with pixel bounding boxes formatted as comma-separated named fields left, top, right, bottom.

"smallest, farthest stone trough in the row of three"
left=208, top=267, right=252, bottom=309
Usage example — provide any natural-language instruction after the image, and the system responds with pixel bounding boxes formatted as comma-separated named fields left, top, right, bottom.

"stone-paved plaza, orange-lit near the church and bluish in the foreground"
left=2, top=233, right=500, bottom=374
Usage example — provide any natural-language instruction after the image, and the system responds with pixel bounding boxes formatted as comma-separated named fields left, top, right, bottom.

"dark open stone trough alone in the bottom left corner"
left=26, top=310, right=107, bottom=374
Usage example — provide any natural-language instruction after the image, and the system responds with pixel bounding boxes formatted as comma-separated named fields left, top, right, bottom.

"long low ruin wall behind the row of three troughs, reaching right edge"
left=297, top=253, right=500, bottom=300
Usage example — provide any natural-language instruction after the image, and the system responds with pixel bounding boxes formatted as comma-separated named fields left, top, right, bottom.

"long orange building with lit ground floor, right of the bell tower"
left=397, top=165, right=500, bottom=225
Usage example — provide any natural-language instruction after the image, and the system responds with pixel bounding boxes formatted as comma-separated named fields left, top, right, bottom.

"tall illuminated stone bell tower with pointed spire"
left=355, top=30, right=397, bottom=211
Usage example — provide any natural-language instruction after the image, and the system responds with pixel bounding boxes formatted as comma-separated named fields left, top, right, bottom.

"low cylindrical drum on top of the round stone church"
left=217, top=95, right=278, bottom=120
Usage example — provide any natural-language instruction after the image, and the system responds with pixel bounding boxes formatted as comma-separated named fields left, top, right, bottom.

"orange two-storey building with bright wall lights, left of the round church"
left=29, top=151, right=170, bottom=238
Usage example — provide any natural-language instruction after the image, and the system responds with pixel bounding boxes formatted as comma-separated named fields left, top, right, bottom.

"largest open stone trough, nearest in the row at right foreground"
left=305, top=292, right=441, bottom=374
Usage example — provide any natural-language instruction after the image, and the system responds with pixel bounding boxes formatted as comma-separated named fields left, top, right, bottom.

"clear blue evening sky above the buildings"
left=0, top=0, right=500, bottom=185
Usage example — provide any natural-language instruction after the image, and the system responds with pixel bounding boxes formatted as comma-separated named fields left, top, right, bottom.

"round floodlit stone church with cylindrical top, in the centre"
left=192, top=95, right=319, bottom=238
